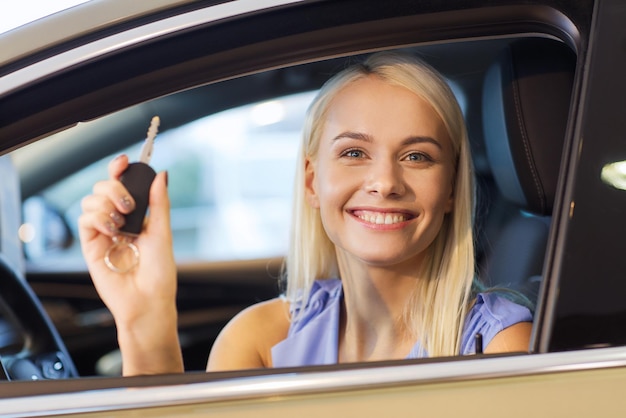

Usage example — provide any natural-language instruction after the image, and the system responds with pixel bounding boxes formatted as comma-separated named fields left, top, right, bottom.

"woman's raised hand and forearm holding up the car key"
left=79, top=156, right=184, bottom=376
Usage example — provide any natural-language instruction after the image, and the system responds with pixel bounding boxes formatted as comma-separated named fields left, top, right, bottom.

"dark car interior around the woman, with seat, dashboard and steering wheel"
left=0, top=31, right=576, bottom=386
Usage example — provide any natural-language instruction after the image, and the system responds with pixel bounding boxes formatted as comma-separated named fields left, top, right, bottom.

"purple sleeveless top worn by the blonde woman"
left=272, top=279, right=532, bottom=367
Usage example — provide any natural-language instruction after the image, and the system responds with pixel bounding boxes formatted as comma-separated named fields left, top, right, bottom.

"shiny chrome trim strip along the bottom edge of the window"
left=0, top=347, right=626, bottom=417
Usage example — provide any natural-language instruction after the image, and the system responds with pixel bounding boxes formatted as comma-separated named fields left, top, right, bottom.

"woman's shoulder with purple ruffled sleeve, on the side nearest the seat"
left=462, top=292, right=532, bottom=354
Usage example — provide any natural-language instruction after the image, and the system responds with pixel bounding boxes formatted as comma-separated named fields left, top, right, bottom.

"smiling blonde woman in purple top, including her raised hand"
left=79, top=50, right=531, bottom=375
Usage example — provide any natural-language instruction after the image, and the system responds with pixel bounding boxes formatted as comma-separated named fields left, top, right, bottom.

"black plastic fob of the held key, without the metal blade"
left=120, top=162, right=156, bottom=235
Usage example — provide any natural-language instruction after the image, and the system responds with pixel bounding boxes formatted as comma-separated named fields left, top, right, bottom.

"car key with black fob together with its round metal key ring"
left=104, top=116, right=160, bottom=273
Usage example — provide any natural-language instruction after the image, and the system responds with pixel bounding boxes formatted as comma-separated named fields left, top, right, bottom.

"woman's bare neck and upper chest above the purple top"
left=338, top=248, right=419, bottom=362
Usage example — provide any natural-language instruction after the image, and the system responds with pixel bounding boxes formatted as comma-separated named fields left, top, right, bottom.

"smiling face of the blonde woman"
left=306, top=76, right=454, bottom=268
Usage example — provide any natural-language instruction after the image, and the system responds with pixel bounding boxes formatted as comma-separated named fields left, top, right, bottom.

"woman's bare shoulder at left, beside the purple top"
left=207, top=298, right=289, bottom=371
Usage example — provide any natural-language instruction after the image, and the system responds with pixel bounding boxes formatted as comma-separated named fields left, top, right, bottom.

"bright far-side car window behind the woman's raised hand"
left=20, top=92, right=315, bottom=265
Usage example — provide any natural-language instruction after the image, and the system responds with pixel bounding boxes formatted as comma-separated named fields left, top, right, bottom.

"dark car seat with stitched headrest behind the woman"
left=479, top=38, right=576, bottom=301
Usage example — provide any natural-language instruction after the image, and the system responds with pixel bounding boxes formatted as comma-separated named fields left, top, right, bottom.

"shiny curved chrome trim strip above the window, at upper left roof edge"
left=0, top=0, right=305, bottom=97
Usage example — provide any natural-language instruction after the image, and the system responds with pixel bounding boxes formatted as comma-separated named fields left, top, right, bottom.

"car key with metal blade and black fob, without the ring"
left=119, top=116, right=160, bottom=236
